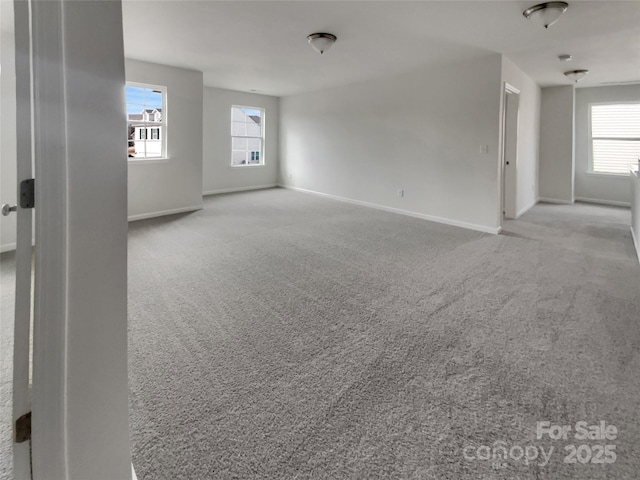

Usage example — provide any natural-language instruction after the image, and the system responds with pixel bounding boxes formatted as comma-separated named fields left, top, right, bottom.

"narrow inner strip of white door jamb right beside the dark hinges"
left=29, top=0, right=70, bottom=479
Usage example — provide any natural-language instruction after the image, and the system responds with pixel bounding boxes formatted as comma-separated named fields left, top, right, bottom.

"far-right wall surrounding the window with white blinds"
left=575, top=84, right=640, bottom=205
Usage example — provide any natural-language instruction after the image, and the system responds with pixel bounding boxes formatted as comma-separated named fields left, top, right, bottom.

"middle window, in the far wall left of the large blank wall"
left=231, top=105, right=264, bottom=167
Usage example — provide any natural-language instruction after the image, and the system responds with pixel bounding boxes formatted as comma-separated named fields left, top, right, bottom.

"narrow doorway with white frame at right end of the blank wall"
left=501, top=83, right=520, bottom=219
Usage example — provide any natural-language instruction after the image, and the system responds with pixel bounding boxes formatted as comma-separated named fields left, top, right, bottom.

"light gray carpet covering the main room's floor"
left=129, top=189, right=640, bottom=480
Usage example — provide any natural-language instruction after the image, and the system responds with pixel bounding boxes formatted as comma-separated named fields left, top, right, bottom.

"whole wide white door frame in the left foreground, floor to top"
left=14, top=0, right=131, bottom=480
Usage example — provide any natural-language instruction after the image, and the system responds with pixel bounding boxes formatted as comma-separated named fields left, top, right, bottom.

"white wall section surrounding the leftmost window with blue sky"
left=125, top=59, right=203, bottom=219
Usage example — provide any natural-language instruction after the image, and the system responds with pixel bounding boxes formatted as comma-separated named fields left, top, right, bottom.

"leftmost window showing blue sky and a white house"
left=126, top=83, right=167, bottom=159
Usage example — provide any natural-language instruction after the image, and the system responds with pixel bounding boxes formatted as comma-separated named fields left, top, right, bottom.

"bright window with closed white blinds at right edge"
left=590, top=103, right=640, bottom=175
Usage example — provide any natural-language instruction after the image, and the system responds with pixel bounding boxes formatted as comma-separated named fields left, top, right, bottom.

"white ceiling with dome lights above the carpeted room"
left=123, top=0, right=640, bottom=96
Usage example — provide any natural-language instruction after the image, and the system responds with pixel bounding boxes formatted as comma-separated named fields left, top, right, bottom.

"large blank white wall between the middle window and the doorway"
left=280, top=54, right=502, bottom=232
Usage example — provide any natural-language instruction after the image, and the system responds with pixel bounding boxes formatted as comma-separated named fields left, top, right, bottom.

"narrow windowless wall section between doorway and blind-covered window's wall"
left=539, top=85, right=574, bottom=203
